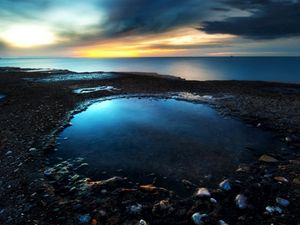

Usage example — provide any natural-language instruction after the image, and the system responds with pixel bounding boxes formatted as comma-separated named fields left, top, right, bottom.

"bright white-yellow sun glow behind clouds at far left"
left=0, top=25, right=55, bottom=48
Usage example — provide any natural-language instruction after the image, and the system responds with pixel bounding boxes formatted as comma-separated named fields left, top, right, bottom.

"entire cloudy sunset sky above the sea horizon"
left=0, top=0, right=300, bottom=57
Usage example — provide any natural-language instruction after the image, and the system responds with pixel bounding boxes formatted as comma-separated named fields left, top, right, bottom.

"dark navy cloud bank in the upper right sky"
left=199, top=0, right=300, bottom=39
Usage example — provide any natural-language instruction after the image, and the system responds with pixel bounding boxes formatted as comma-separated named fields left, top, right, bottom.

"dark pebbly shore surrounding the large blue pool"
left=0, top=68, right=300, bottom=225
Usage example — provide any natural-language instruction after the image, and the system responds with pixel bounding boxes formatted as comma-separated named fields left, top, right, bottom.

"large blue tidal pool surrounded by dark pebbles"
left=54, top=98, right=282, bottom=192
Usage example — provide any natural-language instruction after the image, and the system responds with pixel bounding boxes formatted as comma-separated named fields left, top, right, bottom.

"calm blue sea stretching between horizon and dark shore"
left=0, top=57, right=300, bottom=83
